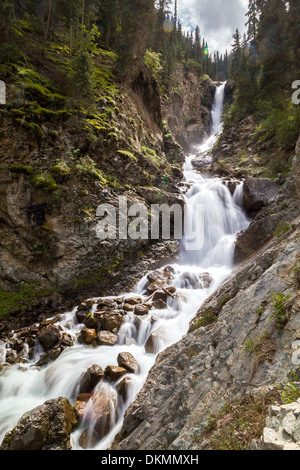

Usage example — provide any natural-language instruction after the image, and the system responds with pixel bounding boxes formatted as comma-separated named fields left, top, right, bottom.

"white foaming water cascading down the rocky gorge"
left=0, top=84, right=248, bottom=450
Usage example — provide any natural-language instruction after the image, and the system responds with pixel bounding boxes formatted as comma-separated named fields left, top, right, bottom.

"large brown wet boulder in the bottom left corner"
left=0, top=397, right=77, bottom=450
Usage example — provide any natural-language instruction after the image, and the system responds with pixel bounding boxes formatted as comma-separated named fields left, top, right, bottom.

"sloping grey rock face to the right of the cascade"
left=113, top=134, right=300, bottom=450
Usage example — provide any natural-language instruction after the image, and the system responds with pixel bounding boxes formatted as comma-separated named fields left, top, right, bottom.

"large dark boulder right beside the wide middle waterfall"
left=243, top=178, right=280, bottom=215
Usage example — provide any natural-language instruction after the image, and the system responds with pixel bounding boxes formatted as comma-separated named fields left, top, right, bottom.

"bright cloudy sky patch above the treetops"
left=173, top=0, right=248, bottom=53
